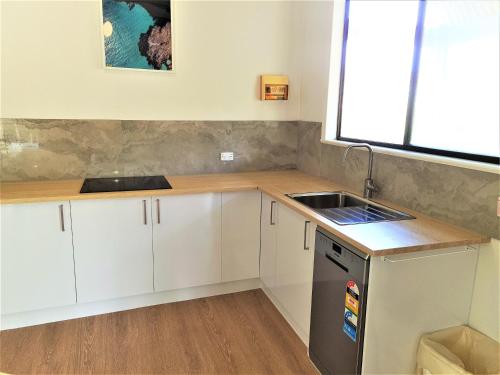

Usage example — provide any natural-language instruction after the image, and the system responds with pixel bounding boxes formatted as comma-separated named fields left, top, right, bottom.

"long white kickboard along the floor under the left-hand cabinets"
left=0, top=278, right=261, bottom=330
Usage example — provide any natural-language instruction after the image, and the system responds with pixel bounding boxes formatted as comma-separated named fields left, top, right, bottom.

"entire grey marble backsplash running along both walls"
left=0, top=119, right=500, bottom=238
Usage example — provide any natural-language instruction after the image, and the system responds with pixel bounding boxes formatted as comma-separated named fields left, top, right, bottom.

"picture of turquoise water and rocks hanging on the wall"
left=101, top=0, right=174, bottom=72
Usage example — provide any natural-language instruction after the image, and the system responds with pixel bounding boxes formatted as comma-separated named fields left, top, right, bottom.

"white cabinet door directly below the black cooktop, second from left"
left=71, top=197, right=153, bottom=303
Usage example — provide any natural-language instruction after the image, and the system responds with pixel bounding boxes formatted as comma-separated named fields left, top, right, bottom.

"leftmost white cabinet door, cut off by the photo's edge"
left=0, top=201, right=76, bottom=314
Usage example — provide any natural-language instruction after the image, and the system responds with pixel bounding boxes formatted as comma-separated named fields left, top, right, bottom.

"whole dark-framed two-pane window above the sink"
left=326, top=0, right=500, bottom=164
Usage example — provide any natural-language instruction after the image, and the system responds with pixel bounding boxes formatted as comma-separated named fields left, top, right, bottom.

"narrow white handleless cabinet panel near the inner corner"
left=222, top=190, right=260, bottom=282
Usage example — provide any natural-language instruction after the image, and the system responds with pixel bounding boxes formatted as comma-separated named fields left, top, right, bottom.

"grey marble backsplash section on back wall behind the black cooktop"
left=0, top=119, right=297, bottom=181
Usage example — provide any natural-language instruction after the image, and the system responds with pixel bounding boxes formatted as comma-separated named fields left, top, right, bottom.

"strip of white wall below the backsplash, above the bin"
left=469, top=239, right=500, bottom=341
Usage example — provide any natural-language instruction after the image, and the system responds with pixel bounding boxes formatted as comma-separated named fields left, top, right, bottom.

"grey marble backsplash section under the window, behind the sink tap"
left=298, top=122, right=500, bottom=238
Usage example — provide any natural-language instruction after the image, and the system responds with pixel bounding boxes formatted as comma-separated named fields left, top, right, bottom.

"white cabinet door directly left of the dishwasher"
left=273, top=204, right=316, bottom=337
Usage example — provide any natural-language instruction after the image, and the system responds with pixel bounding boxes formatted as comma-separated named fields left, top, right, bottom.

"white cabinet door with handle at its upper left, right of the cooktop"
left=153, top=193, right=221, bottom=291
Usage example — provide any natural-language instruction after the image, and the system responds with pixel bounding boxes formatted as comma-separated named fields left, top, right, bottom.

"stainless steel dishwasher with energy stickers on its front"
left=309, top=228, right=370, bottom=375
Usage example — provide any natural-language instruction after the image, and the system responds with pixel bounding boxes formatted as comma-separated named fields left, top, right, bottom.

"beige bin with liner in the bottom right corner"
left=417, top=326, right=500, bottom=375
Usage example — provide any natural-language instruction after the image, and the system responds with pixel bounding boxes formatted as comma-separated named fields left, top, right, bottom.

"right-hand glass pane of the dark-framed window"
left=411, top=0, right=500, bottom=156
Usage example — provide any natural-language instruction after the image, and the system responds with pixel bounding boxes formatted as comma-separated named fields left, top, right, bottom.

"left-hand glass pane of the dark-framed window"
left=341, top=1, right=418, bottom=144
